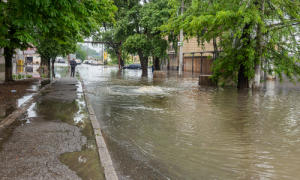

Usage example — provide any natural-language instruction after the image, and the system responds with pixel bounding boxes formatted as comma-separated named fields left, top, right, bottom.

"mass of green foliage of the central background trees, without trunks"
left=96, top=0, right=172, bottom=72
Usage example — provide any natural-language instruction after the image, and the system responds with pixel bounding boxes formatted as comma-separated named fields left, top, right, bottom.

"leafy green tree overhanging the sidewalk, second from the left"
left=37, top=0, right=114, bottom=78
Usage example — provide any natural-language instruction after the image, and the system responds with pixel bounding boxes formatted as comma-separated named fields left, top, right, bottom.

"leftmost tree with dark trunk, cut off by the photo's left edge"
left=0, top=0, right=41, bottom=82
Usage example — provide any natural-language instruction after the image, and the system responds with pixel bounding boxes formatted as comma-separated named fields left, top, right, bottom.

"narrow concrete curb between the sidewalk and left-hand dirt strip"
left=0, top=80, right=56, bottom=130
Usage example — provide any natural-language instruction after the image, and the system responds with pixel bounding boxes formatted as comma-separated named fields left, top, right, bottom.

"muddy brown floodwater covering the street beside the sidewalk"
left=80, top=65, right=300, bottom=180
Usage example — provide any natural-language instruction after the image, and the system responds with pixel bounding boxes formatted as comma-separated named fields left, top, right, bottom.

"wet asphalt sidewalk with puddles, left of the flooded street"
left=0, top=78, right=104, bottom=180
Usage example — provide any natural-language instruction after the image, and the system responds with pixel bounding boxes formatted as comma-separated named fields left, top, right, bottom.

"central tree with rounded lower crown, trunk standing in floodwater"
left=120, top=0, right=170, bottom=76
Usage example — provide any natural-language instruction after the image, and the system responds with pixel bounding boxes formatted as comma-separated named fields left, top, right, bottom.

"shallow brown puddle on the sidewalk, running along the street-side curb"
left=33, top=83, right=105, bottom=180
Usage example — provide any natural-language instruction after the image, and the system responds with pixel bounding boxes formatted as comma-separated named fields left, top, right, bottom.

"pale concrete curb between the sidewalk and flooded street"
left=81, top=81, right=118, bottom=180
